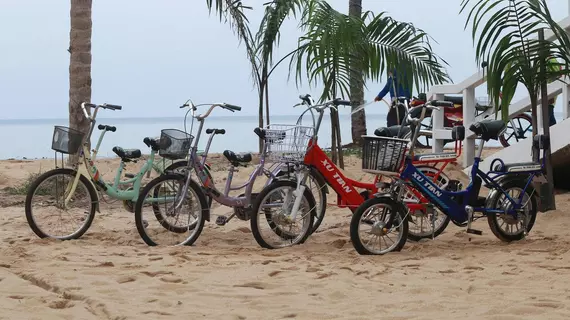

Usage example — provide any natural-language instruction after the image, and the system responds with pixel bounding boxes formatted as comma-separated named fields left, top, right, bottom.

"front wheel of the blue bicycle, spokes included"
left=350, top=197, right=408, bottom=255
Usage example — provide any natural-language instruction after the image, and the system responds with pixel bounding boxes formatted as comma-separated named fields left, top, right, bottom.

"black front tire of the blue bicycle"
left=350, top=197, right=409, bottom=255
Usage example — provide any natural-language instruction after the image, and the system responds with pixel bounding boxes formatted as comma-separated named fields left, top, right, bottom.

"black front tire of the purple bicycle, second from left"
left=135, top=174, right=209, bottom=246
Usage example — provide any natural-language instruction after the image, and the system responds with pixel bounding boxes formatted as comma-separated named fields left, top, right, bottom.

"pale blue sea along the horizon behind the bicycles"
left=0, top=113, right=562, bottom=159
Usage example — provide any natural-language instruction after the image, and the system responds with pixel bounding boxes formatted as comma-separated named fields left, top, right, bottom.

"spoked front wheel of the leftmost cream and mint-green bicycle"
left=25, top=168, right=98, bottom=240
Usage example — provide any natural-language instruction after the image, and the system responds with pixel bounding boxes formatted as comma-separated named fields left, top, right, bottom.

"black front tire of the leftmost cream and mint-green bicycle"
left=25, top=168, right=99, bottom=240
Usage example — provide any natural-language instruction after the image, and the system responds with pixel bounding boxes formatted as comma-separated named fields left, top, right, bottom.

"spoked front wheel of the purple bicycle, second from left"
left=135, top=174, right=209, bottom=246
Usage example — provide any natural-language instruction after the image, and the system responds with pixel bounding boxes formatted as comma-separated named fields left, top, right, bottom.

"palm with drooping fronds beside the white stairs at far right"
left=460, top=0, right=570, bottom=210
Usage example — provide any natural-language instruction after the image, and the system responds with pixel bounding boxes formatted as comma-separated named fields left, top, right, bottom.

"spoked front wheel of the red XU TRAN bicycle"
left=251, top=180, right=316, bottom=249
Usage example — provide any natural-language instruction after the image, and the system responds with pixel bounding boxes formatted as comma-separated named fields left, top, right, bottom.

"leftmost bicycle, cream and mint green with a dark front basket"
left=25, top=103, right=189, bottom=240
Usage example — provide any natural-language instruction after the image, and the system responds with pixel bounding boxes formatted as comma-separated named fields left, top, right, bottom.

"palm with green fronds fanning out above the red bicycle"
left=290, top=0, right=450, bottom=165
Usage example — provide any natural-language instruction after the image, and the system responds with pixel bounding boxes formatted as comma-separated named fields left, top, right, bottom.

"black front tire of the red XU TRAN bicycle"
left=250, top=180, right=316, bottom=249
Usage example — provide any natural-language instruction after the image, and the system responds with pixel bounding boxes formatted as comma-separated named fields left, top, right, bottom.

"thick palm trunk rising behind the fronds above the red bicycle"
left=348, top=0, right=366, bottom=145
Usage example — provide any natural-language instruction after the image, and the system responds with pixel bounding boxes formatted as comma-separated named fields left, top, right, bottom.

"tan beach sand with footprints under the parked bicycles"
left=0, top=151, right=570, bottom=320
